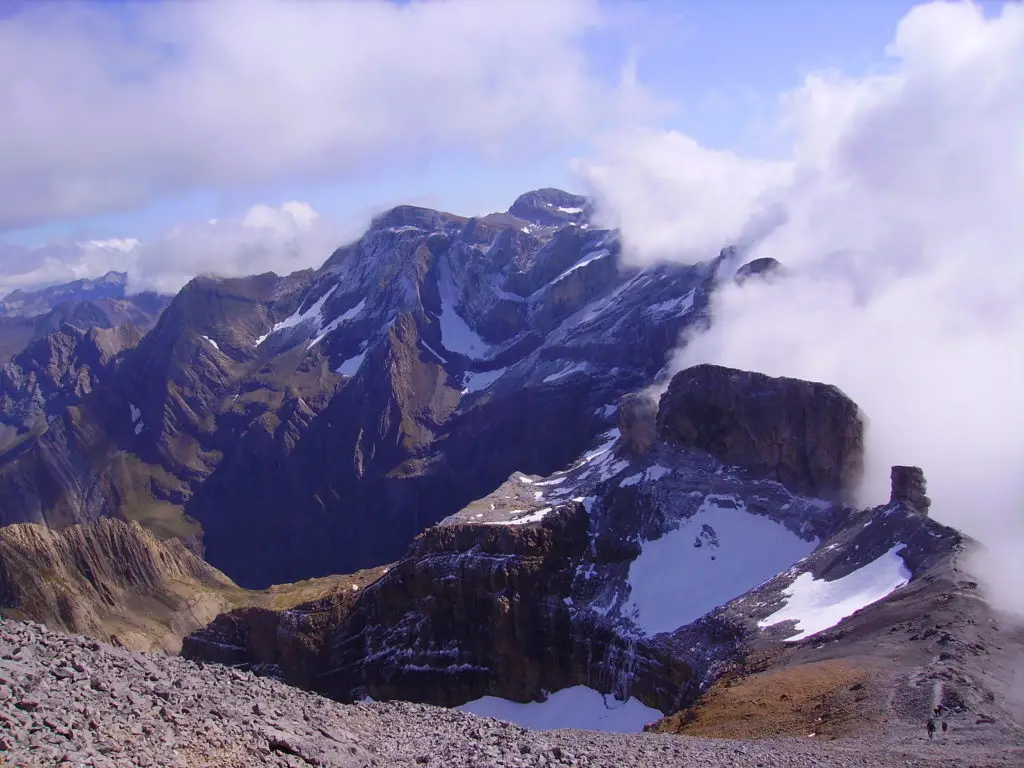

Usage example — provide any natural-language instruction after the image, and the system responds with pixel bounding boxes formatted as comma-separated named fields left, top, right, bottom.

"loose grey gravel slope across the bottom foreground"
left=0, top=620, right=1024, bottom=768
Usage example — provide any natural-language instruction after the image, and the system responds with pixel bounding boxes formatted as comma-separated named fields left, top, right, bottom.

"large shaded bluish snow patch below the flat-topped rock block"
left=622, top=496, right=817, bottom=635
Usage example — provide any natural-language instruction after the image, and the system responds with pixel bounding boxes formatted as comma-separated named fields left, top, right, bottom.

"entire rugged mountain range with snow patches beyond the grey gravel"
left=0, top=188, right=1024, bottom=765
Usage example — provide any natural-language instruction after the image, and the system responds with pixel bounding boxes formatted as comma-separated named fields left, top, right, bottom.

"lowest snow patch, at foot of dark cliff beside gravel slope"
left=457, top=685, right=663, bottom=733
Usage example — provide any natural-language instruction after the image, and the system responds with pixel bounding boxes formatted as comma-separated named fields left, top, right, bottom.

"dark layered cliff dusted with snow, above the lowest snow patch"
left=182, top=503, right=712, bottom=711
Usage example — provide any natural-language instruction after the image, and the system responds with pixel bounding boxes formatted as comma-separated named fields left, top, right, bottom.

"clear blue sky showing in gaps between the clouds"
left=0, top=0, right=937, bottom=246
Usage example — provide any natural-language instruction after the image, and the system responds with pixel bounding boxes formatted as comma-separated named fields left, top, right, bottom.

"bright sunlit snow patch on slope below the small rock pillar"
left=758, top=544, right=913, bottom=642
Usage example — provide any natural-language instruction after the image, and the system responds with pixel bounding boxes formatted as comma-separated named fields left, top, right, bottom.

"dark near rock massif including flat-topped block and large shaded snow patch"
left=182, top=367, right=958, bottom=733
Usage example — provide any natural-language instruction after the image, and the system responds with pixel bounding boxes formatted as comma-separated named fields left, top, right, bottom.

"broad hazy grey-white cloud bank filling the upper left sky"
left=0, top=0, right=630, bottom=230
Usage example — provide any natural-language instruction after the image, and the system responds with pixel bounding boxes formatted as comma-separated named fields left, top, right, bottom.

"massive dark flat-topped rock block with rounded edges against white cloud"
left=657, top=365, right=864, bottom=498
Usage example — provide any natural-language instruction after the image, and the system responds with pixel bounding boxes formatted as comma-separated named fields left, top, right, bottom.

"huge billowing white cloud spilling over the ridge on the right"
left=580, top=3, right=1024, bottom=613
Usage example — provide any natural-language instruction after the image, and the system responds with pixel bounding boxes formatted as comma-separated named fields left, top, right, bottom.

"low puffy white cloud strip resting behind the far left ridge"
left=0, top=201, right=360, bottom=295
